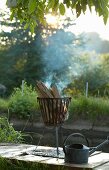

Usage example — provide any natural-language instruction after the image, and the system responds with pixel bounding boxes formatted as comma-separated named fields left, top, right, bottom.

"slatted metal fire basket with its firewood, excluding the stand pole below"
left=36, top=81, right=71, bottom=126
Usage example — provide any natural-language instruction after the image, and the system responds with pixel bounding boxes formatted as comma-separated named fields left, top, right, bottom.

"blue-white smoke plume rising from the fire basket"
left=43, top=29, right=109, bottom=89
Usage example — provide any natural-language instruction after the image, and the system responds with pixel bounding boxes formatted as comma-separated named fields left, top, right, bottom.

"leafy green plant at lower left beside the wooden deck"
left=0, top=117, right=23, bottom=143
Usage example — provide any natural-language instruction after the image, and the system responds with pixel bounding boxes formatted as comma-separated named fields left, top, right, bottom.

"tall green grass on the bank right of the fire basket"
left=69, top=96, right=109, bottom=120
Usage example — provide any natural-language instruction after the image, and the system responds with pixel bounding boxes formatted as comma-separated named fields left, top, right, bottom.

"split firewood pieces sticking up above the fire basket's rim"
left=36, top=81, right=61, bottom=98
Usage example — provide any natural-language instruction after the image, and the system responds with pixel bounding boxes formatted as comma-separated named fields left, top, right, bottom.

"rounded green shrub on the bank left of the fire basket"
left=9, top=82, right=38, bottom=118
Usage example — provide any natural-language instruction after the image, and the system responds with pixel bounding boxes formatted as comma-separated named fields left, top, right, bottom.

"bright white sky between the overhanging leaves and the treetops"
left=0, top=0, right=109, bottom=40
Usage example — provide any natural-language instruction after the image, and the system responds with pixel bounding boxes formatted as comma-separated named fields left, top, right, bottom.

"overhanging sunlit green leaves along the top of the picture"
left=7, top=0, right=109, bottom=32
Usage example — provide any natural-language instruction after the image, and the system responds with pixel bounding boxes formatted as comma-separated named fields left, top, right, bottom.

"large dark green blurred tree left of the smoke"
left=0, top=11, right=45, bottom=94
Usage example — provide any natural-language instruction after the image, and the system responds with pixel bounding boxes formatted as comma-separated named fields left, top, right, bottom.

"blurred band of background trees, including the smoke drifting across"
left=0, top=10, right=109, bottom=95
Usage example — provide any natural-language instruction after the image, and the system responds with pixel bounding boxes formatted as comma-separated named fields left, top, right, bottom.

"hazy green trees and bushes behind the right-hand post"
left=63, top=54, right=109, bottom=96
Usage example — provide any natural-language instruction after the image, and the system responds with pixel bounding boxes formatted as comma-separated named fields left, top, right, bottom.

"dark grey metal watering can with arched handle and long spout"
left=63, top=133, right=109, bottom=164
